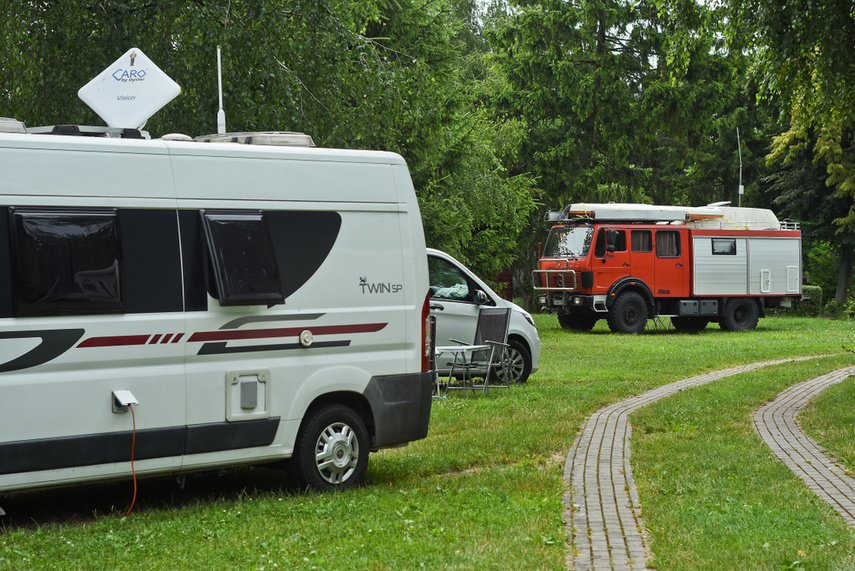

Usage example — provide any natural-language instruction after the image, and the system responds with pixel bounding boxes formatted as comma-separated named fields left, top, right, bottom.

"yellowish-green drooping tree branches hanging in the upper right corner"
left=660, top=0, right=855, bottom=301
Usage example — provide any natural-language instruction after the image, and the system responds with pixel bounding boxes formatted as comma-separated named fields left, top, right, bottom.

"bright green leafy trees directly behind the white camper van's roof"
left=0, top=0, right=533, bottom=275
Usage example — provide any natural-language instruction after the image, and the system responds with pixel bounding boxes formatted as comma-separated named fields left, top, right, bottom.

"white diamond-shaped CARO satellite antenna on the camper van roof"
left=77, top=48, right=181, bottom=129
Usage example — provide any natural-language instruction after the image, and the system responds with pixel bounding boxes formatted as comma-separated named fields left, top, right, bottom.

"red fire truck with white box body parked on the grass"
left=534, top=203, right=802, bottom=333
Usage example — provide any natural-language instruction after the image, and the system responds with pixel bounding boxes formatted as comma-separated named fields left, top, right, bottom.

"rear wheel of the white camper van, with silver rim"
left=289, top=404, right=370, bottom=491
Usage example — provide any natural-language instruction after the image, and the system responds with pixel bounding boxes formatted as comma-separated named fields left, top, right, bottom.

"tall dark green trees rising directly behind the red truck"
left=488, top=0, right=766, bottom=212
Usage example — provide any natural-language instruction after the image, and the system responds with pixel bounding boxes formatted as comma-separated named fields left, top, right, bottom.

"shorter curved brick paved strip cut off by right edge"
left=754, top=367, right=855, bottom=527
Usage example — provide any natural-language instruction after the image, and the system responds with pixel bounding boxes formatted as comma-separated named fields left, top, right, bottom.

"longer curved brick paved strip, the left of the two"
left=564, top=359, right=804, bottom=571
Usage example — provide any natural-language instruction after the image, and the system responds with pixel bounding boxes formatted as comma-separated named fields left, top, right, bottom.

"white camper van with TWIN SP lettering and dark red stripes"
left=0, top=121, right=432, bottom=492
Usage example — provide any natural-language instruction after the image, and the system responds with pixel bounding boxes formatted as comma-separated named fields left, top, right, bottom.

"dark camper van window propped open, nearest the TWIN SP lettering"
left=201, top=210, right=285, bottom=306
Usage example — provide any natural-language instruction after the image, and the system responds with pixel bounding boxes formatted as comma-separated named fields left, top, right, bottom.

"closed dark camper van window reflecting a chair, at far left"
left=9, top=208, right=123, bottom=316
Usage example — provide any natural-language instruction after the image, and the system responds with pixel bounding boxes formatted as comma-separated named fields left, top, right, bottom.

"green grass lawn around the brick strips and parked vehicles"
left=0, top=315, right=855, bottom=570
